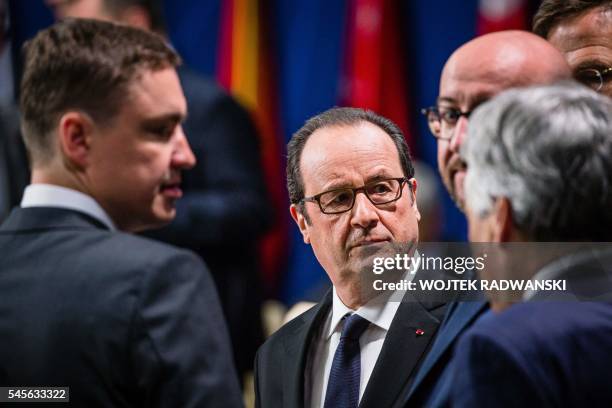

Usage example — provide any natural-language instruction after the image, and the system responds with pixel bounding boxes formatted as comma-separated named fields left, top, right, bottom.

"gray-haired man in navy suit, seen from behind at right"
left=453, top=82, right=612, bottom=407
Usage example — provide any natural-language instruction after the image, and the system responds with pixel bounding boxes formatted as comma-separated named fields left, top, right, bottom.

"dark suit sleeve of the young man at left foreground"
left=131, top=251, right=242, bottom=407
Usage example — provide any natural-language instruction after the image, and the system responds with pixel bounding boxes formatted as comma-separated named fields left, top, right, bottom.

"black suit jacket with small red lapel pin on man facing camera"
left=255, top=286, right=446, bottom=408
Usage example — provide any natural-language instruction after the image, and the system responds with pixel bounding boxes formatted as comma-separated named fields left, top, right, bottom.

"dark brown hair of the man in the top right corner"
left=533, top=0, right=612, bottom=38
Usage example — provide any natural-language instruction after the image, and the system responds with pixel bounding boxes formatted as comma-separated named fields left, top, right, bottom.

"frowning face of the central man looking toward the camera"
left=291, top=122, right=420, bottom=286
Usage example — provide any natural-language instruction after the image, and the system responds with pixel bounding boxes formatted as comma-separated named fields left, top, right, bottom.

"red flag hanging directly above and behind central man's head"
left=340, top=0, right=414, bottom=149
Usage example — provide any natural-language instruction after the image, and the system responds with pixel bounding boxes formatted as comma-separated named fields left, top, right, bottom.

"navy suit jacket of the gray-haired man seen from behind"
left=453, top=251, right=612, bottom=407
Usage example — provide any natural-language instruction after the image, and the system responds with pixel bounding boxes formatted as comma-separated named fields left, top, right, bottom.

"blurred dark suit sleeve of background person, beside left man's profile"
left=148, top=85, right=272, bottom=247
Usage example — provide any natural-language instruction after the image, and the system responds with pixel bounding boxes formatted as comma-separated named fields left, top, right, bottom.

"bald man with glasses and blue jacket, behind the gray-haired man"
left=406, top=31, right=570, bottom=407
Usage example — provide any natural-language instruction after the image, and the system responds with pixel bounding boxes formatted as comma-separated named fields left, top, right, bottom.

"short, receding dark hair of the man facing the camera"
left=287, top=108, right=414, bottom=212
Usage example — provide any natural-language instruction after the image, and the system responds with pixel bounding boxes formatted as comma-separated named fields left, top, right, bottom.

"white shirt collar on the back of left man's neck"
left=21, top=184, right=117, bottom=231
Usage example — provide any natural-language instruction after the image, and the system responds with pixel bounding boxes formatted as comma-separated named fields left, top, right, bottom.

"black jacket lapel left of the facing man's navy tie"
left=282, top=290, right=332, bottom=408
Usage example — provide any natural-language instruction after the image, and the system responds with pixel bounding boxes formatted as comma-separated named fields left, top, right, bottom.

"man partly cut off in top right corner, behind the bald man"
left=533, top=0, right=612, bottom=97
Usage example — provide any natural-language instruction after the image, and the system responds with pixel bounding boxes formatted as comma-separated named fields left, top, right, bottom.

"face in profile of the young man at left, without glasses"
left=85, top=68, right=195, bottom=231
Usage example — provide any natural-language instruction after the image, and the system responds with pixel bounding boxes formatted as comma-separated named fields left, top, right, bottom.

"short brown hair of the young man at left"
left=20, top=19, right=180, bottom=162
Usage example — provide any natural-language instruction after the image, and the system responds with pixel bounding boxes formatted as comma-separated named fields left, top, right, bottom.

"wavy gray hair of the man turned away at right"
left=461, top=81, right=612, bottom=241
